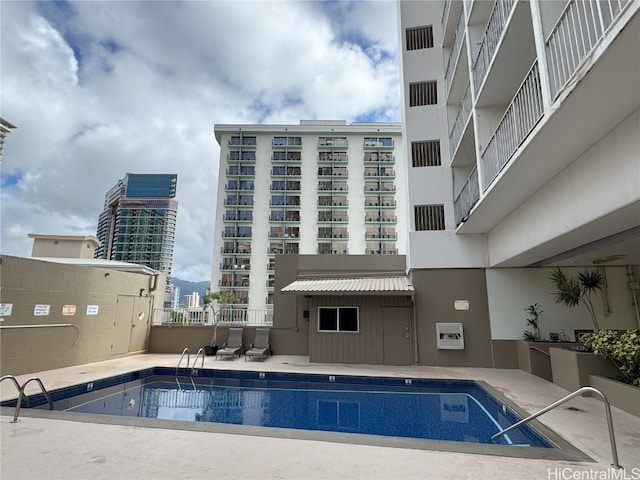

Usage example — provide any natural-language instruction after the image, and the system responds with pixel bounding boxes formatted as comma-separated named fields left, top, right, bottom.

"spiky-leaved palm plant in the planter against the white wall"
left=550, top=268, right=603, bottom=333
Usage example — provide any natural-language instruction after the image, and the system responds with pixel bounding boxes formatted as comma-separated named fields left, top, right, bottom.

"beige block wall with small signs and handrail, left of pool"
left=0, top=255, right=161, bottom=375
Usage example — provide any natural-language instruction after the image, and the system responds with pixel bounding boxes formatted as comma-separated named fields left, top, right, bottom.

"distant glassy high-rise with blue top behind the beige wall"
left=94, top=173, right=178, bottom=276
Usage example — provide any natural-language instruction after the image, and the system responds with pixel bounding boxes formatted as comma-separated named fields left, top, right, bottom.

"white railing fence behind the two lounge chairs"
left=152, top=308, right=273, bottom=326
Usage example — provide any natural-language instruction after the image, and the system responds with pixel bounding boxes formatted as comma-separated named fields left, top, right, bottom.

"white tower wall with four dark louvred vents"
left=398, top=1, right=488, bottom=269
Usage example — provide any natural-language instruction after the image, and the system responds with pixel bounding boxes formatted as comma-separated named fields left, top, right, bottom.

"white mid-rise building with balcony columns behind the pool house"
left=212, top=121, right=408, bottom=309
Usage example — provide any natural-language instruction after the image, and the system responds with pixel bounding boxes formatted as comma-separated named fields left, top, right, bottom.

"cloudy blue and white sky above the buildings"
left=0, top=0, right=400, bottom=280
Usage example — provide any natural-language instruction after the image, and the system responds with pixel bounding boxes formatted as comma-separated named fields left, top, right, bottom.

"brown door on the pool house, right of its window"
left=382, top=307, right=412, bottom=365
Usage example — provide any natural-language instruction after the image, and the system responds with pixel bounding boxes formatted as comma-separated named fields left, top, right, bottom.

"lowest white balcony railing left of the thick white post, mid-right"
left=480, top=61, right=543, bottom=192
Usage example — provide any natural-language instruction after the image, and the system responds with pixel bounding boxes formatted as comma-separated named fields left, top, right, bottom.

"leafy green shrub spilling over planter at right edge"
left=582, top=330, right=640, bottom=387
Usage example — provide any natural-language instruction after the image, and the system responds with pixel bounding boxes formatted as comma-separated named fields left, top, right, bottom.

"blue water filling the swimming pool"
left=3, top=367, right=554, bottom=448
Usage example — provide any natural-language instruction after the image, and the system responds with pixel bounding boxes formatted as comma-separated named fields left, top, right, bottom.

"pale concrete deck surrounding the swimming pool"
left=0, top=354, right=640, bottom=480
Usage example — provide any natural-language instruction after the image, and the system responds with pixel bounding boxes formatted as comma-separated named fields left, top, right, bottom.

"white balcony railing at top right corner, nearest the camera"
left=545, top=0, right=631, bottom=99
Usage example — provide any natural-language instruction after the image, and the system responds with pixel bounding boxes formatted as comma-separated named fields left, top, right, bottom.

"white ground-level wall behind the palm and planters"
left=486, top=267, right=638, bottom=340
